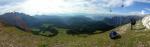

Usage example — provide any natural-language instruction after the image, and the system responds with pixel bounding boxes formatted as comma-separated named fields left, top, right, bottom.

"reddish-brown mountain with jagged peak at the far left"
left=0, top=12, right=29, bottom=31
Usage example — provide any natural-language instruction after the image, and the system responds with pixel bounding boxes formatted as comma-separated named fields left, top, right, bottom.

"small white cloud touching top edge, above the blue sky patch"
left=95, top=0, right=134, bottom=8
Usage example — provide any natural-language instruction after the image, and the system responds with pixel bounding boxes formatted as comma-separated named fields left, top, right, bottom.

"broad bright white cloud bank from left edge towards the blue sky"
left=0, top=0, right=148, bottom=15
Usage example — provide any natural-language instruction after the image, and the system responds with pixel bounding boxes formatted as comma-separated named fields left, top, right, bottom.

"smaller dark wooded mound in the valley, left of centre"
left=32, top=24, right=58, bottom=37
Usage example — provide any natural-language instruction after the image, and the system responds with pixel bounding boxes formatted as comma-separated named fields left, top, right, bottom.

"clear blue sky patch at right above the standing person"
left=113, top=2, right=150, bottom=14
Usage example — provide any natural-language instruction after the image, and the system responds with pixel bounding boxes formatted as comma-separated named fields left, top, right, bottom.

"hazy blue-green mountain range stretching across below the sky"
left=0, top=12, right=142, bottom=31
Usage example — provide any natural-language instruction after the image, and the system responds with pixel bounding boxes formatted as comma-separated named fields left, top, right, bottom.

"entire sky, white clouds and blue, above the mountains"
left=0, top=0, right=150, bottom=15
